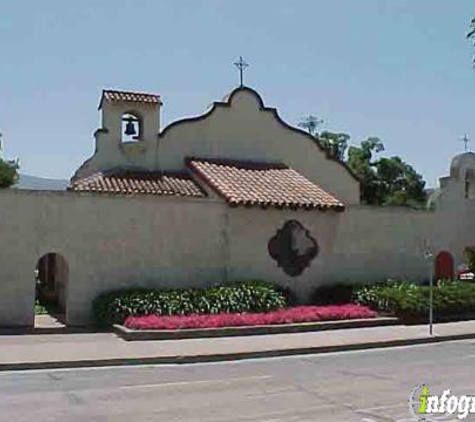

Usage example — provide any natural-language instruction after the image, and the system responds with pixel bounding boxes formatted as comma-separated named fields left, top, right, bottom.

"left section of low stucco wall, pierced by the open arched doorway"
left=0, top=190, right=225, bottom=326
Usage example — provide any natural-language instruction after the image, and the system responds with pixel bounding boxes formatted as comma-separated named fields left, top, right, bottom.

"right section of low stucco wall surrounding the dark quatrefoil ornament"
left=228, top=206, right=435, bottom=300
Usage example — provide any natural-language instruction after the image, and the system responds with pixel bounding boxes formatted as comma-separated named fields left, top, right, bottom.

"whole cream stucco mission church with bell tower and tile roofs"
left=0, top=86, right=475, bottom=326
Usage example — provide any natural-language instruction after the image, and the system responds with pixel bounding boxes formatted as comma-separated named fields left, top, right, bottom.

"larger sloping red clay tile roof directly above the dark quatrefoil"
left=187, top=158, right=344, bottom=211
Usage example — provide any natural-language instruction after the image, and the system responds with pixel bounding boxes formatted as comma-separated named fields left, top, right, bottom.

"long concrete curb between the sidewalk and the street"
left=0, top=333, right=475, bottom=372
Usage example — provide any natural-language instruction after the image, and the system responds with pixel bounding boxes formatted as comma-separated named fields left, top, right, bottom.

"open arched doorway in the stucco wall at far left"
left=35, top=252, right=69, bottom=323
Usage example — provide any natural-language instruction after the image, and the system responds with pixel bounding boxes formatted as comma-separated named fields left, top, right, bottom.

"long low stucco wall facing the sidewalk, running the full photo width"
left=0, top=186, right=475, bottom=326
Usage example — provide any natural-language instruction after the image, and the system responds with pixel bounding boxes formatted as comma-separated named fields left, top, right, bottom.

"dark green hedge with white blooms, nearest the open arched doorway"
left=93, top=281, right=287, bottom=326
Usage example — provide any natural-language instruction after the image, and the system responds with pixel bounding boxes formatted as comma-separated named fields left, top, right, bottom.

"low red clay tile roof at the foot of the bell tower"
left=68, top=171, right=206, bottom=197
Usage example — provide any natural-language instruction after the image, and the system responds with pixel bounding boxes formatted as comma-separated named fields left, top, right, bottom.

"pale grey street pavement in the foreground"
left=0, top=340, right=475, bottom=422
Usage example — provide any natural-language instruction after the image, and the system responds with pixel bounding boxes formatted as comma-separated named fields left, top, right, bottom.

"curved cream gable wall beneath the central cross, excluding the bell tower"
left=158, top=87, right=359, bottom=204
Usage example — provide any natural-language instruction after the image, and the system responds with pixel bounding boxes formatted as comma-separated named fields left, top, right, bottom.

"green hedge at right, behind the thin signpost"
left=354, top=281, right=475, bottom=319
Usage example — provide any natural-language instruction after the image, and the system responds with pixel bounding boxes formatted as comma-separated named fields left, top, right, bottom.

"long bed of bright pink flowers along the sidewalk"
left=125, top=304, right=376, bottom=330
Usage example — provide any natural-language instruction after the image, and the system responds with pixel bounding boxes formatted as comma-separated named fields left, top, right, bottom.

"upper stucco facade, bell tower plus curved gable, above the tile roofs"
left=72, top=87, right=360, bottom=204
